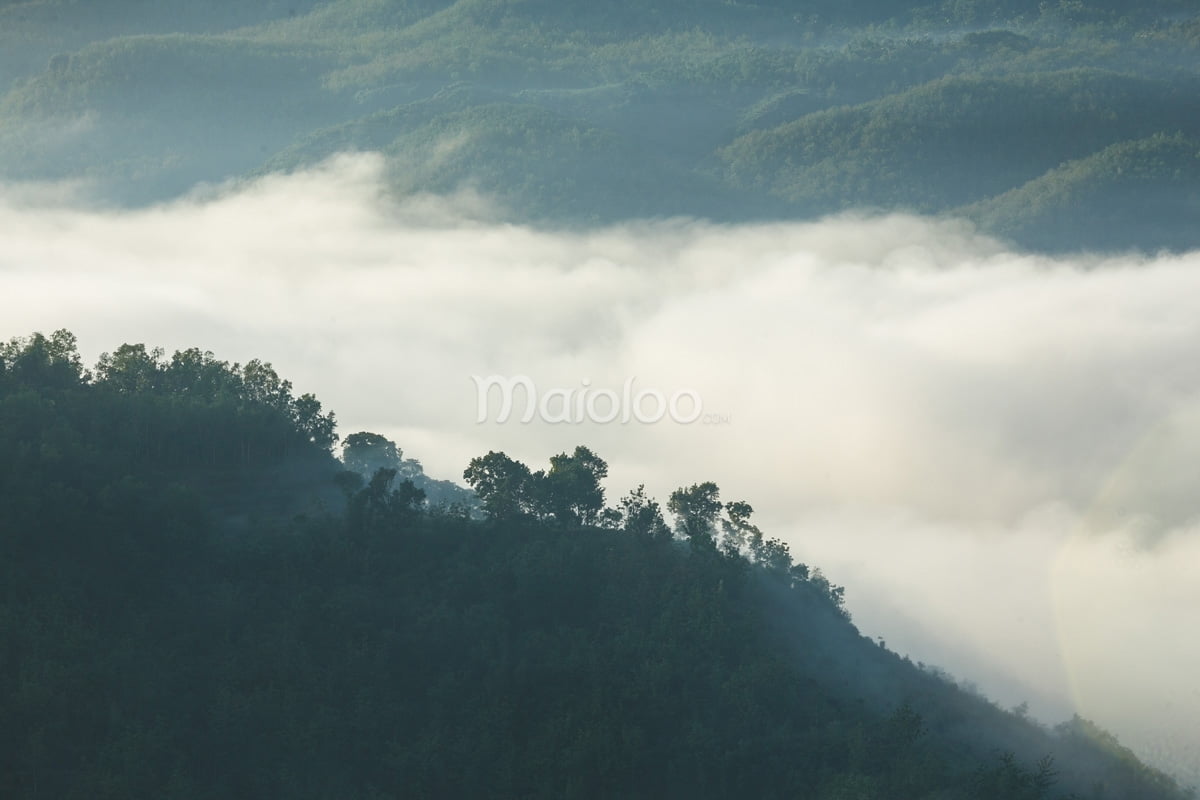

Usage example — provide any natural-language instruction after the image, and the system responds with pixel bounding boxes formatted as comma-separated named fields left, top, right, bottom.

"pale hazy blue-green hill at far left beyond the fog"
left=0, top=34, right=344, bottom=201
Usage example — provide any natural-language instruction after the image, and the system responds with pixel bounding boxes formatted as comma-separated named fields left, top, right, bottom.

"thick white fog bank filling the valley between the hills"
left=7, top=156, right=1200, bottom=780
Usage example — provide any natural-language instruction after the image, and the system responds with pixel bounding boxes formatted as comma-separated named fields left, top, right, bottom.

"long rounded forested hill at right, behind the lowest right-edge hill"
left=722, top=70, right=1200, bottom=211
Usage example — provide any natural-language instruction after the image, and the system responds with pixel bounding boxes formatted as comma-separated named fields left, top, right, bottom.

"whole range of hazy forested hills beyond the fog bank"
left=0, top=0, right=1200, bottom=251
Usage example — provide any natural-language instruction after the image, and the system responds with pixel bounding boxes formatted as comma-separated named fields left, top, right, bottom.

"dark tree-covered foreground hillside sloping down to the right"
left=0, top=331, right=1187, bottom=800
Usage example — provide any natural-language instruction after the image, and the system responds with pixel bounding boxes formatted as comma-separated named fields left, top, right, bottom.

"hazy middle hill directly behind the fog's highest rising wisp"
left=262, top=93, right=763, bottom=223
